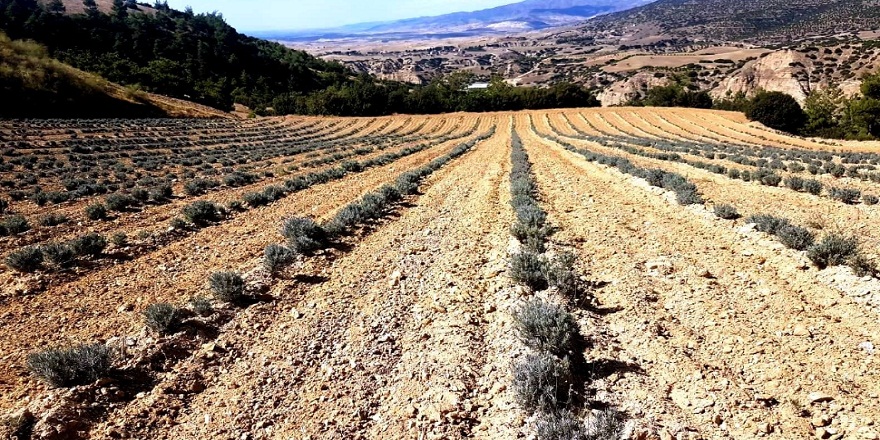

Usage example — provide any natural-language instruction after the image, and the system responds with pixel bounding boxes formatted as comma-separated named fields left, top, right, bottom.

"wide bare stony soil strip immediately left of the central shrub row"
left=93, top=115, right=512, bottom=438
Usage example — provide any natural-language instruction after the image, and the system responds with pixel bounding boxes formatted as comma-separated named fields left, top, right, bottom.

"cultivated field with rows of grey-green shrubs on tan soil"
left=0, top=108, right=880, bottom=440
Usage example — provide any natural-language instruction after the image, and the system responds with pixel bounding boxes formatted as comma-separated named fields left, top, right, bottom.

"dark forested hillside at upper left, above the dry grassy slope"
left=0, top=0, right=351, bottom=110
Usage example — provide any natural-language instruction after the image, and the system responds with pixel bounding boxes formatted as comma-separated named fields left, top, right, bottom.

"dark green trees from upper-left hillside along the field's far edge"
left=0, top=0, right=598, bottom=116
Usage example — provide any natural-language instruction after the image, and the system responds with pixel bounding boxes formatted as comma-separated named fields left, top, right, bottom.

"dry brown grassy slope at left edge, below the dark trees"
left=0, top=33, right=228, bottom=118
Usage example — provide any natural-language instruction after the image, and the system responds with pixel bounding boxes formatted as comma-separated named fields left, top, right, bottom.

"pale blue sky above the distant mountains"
left=162, top=0, right=517, bottom=32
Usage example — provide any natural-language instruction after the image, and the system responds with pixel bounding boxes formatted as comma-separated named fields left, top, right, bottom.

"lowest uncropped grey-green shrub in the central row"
left=513, top=353, right=572, bottom=413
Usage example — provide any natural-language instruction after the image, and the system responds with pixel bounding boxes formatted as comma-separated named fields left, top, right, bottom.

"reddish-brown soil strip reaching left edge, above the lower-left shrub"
left=0, top=119, right=488, bottom=409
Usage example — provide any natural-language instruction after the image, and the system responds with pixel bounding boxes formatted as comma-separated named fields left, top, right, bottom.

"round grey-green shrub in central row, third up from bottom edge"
left=513, top=299, right=582, bottom=357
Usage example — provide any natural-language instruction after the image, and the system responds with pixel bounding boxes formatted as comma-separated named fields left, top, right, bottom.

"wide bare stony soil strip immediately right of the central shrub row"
left=525, top=120, right=880, bottom=439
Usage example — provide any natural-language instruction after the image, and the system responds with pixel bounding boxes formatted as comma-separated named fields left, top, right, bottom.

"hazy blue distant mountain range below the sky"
left=255, top=0, right=653, bottom=41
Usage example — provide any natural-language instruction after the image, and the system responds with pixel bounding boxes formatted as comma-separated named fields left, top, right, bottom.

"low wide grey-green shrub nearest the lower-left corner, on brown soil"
left=27, top=344, right=112, bottom=388
